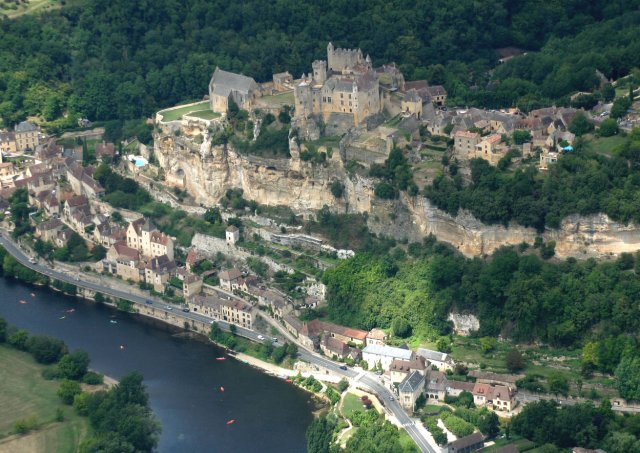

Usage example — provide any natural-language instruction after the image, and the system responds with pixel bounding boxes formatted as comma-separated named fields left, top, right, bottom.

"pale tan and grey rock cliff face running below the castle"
left=155, top=130, right=640, bottom=258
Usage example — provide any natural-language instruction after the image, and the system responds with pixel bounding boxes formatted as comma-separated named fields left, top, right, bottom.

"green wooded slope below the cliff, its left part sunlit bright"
left=324, top=237, right=640, bottom=346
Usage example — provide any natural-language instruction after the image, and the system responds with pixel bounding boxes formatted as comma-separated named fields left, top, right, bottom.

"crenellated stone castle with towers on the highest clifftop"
left=294, top=43, right=382, bottom=126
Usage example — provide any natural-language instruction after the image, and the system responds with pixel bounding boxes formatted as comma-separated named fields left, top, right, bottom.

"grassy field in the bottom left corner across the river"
left=0, top=346, right=89, bottom=452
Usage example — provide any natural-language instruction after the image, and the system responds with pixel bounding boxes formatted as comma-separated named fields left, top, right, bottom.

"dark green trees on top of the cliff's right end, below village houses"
left=425, top=129, right=640, bottom=231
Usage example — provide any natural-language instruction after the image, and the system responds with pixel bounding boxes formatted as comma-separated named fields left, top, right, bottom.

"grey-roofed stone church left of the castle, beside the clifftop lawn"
left=209, top=66, right=259, bottom=114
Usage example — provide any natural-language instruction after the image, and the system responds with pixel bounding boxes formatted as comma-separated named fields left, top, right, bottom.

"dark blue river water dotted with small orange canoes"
left=0, top=277, right=313, bottom=453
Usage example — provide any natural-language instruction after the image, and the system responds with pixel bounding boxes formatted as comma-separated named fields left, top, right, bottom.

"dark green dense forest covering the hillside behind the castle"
left=0, top=0, right=640, bottom=128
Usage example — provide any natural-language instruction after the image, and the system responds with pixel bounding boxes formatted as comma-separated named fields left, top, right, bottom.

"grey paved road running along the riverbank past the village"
left=0, top=233, right=437, bottom=453
